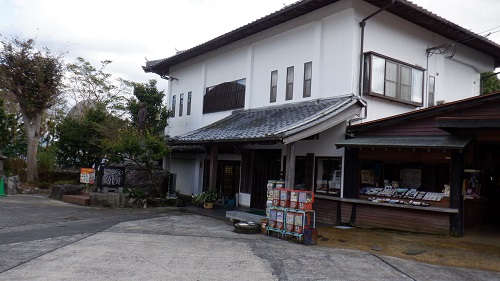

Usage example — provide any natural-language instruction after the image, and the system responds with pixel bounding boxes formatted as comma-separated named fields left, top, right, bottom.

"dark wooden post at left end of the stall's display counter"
left=343, top=147, right=361, bottom=198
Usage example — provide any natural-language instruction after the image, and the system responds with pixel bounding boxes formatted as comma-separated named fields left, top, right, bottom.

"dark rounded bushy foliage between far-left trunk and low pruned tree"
left=55, top=103, right=123, bottom=168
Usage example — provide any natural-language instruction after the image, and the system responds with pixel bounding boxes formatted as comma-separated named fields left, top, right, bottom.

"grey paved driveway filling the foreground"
left=0, top=195, right=500, bottom=281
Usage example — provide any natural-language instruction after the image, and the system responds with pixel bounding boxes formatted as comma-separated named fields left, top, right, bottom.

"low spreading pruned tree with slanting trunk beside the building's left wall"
left=103, top=125, right=170, bottom=197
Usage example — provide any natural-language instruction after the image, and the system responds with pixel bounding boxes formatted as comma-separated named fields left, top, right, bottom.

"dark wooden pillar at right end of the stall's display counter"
left=450, top=150, right=464, bottom=237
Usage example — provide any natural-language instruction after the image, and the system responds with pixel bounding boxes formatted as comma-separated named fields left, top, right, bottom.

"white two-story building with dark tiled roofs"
left=143, top=0, right=500, bottom=225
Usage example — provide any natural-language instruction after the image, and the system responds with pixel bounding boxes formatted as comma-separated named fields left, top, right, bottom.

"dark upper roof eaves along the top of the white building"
left=143, top=0, right=500, bottom=76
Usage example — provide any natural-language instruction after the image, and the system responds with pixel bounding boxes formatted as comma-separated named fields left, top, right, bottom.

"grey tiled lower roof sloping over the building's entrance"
left=172, top=95, right=363, bottom=144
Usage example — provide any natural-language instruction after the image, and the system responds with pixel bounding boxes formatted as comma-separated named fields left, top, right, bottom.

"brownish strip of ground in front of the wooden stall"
left=317, top=226, right=500, bottom=272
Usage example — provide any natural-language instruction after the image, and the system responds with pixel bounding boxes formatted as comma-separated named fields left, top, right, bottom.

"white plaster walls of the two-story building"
left=166, top=1, right=494, bottom=195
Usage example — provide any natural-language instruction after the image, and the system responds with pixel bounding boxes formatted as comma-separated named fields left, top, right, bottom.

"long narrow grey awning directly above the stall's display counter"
left=335, top=136, right=472, bottom=149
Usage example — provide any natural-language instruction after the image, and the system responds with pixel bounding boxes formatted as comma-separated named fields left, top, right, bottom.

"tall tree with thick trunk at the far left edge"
left=0, top=37, right=64, bottom=181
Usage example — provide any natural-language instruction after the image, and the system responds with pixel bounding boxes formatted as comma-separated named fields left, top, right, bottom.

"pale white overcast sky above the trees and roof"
left=0, top=0, right=500, bottom=87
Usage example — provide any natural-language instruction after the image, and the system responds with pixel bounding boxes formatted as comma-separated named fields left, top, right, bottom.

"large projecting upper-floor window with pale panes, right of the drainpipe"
left=364, top=53, right=424, bottom=106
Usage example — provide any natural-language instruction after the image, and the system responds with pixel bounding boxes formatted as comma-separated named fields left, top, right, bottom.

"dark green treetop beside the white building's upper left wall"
left=127, top=79, right=169, bottom=136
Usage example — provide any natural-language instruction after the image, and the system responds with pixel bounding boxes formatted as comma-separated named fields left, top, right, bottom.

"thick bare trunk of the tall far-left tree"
left=23, top=114, right=42, bottom=182
